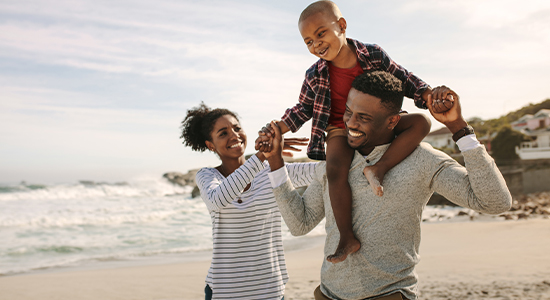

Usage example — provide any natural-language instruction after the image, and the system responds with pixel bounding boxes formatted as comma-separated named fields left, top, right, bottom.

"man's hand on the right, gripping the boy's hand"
left=428, top=85, right=468, bottom=133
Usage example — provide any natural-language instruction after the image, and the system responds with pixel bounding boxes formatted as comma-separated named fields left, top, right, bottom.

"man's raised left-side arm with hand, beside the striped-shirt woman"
left=266, top=123, right=325, bottom=236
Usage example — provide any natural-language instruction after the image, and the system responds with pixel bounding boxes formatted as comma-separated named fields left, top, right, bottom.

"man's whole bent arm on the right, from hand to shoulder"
left=428, top=86, right=512, bottom=214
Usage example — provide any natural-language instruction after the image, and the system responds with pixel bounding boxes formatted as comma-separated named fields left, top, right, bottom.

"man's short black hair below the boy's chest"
left=351, top=71, right=404, bottom=115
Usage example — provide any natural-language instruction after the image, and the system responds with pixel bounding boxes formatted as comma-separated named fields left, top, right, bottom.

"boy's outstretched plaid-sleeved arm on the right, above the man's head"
left=369, top=45, right=431, bottom=109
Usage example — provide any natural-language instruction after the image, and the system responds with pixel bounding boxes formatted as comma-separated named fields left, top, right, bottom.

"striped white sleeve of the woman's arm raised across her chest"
left=196, top=155, right=265, bottom=212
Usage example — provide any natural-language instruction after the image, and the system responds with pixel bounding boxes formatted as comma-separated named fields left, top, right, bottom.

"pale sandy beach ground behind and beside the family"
left=0, top=219, right=550, bottom=300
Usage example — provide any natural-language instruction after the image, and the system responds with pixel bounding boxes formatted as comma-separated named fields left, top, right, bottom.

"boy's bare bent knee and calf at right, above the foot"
left=376, top=114, right=431, bottom=180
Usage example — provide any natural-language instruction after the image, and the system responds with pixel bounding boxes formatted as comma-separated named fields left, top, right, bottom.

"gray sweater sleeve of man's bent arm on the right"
left=432, top=147, right=512, bottom=214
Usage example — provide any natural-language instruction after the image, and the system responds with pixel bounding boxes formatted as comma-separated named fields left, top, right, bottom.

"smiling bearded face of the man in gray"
left=344, top=88, right=399, bottom=155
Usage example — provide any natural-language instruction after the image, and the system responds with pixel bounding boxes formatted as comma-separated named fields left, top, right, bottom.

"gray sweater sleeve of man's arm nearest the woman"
left=273, top=163, right=325, bottom=236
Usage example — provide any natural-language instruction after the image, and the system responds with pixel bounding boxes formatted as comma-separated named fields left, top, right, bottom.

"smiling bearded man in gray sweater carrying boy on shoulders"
left=268, top=71, right=512, bottom=300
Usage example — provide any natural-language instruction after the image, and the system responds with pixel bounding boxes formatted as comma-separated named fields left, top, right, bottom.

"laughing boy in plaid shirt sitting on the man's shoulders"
left=259, top=1, right=446, bottom=263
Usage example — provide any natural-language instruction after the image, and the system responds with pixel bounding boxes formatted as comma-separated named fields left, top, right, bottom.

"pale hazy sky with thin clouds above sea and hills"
left=0, top=0, right=550, bottom=184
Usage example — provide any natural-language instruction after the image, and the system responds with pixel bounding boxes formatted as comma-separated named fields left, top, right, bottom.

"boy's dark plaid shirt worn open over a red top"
left=281, top=39, right=429, bottom=160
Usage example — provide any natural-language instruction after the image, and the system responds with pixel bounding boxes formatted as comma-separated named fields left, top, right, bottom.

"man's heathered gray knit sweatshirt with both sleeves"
left=274, top=143, right=512, bottom=299
